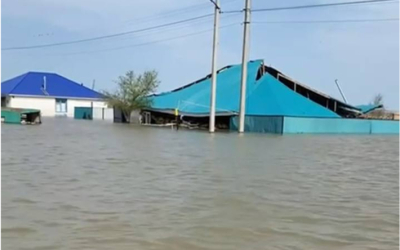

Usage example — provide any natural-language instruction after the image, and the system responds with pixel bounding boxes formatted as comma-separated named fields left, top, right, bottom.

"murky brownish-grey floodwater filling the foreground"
left=1, top=119, right=399, bottom=250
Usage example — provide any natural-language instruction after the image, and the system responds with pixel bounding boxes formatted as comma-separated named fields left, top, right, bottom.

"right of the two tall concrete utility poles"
left=239, top=0, right=251, bottom=133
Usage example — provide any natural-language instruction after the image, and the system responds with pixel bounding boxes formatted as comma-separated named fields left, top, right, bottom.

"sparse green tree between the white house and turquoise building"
left=104, top=70, right=160, bottom=121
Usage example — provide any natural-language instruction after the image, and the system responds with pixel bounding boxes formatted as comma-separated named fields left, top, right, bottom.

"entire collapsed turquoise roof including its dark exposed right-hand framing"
left=149, top=60, right=363, bottom=117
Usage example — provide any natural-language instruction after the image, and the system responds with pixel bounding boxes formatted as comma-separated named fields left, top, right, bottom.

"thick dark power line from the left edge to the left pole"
left=1, top=14, right=213, bottom=51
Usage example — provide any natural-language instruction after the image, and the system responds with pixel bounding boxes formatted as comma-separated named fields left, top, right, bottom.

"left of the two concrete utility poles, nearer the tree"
left=209, top=0, right=221, bottom=133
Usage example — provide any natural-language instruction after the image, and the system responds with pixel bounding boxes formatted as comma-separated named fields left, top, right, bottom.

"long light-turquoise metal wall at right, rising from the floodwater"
left=283, top=117, right=399, bottom=134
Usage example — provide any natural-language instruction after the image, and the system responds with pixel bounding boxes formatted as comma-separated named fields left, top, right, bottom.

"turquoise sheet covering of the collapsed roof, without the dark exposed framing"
left=151, top=60, right=340, bottom=117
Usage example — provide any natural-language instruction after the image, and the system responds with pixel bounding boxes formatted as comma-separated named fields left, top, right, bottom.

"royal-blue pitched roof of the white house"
left=1, top=72, right=103, bottom=99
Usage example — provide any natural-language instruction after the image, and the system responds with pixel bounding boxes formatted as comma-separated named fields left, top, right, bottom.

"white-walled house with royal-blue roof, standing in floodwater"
left=1, top=72, right=107, bottom=117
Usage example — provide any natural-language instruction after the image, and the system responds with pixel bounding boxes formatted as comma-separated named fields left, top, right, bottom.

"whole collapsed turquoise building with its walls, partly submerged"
left=143, top=60, right=399, bottom=134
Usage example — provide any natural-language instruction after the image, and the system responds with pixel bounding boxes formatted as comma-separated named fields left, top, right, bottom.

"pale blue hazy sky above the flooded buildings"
left=1, top=0, right=399, bottom=110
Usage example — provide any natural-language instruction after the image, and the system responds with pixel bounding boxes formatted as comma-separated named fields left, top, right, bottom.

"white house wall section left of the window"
left=8, top=96, right=56, bottom=116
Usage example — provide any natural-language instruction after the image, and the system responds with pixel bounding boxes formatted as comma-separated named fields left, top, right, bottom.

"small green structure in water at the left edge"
left=1, top=108, right=42, bottom=124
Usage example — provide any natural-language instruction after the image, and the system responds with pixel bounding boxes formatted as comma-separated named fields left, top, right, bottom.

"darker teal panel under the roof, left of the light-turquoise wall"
left=230, top=116, right=283, bottom=134
